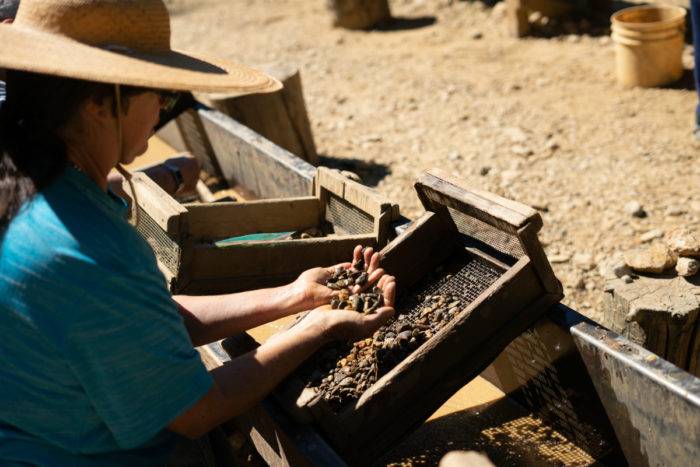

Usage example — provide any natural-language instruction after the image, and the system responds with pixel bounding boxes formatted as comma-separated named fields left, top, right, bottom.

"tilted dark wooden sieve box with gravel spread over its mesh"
left=262, top=170, right=562, bottom=465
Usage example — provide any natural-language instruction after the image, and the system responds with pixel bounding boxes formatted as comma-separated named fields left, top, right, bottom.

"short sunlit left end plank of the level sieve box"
left=130, top=172, right=187, bottom=236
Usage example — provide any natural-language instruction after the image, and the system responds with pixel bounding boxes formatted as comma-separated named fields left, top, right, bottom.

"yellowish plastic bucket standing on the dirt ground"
left=611, top=6, right=686, bottom=87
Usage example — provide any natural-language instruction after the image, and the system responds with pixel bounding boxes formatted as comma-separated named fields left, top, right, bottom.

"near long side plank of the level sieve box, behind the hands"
left=188, top=235, right=376, bottom=280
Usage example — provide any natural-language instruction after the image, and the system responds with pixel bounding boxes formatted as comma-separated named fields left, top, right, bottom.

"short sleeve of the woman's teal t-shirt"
left=42, top=255, right=212, bottom=449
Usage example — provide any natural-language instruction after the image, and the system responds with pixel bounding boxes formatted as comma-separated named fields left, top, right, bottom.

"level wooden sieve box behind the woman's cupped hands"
left=133, top=167, right=398, bottom=294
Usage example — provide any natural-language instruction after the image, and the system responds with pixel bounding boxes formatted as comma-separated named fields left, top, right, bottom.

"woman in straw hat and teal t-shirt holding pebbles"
left=0, top=0, right=395, bottom=465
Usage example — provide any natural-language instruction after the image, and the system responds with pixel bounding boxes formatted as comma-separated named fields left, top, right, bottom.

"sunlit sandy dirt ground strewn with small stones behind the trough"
left=168, top=0, right=700, bottom=318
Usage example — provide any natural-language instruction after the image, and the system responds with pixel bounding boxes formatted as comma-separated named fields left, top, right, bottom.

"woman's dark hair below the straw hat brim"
left=0, top=70, right=143, bottom=232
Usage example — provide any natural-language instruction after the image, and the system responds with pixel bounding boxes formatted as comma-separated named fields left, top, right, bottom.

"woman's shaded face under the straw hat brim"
left=119, top=91, right=161, bottom=164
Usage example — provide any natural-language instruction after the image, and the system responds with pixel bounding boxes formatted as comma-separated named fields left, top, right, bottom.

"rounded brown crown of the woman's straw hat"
left=14, top=0, right=170, bottom=53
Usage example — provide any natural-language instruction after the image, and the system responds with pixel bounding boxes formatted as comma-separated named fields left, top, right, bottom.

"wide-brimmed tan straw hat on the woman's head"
left=0, top=0, right=281, bottom=94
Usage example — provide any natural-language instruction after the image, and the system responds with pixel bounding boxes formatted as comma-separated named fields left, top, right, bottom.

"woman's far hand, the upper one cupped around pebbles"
left=291, top=245, right=393, bottom=310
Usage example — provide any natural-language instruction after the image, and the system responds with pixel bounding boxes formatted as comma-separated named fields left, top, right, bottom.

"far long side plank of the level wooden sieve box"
left=185, top=196, right=321, bottom=240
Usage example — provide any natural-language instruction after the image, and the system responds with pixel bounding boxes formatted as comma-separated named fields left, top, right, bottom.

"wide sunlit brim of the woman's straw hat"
left=0, top=24, right=282, bottom=95
